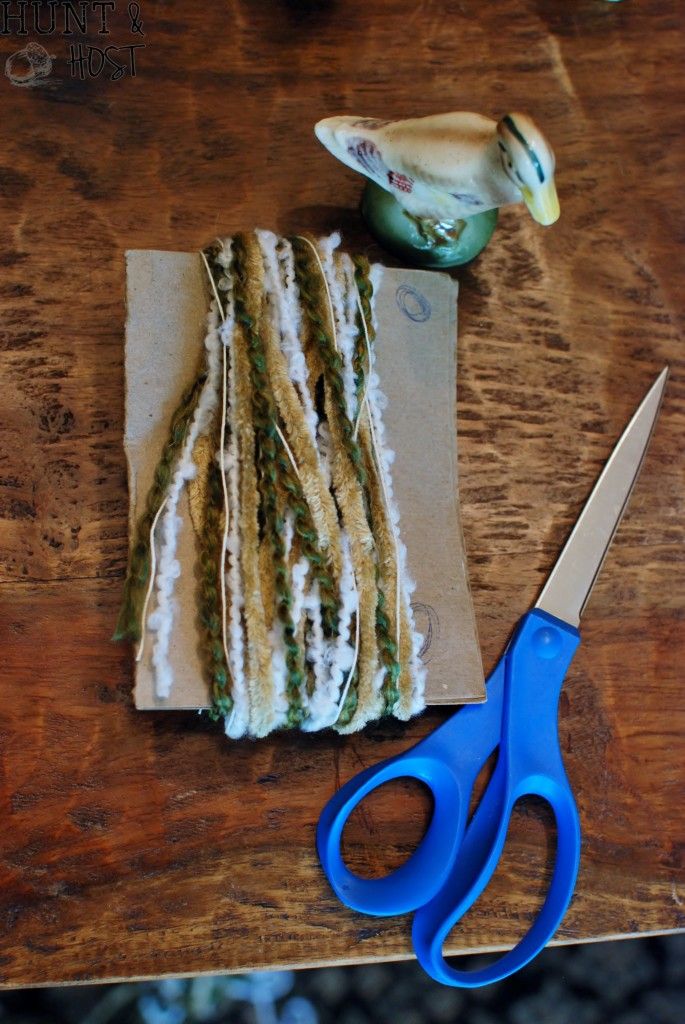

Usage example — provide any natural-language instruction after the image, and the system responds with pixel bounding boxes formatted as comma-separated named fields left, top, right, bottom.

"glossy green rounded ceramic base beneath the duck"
left=361, top=181, right=498, bottom=268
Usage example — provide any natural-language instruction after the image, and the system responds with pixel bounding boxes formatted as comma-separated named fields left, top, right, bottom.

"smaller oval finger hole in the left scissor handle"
left=341, top=778, right=433, bottom=879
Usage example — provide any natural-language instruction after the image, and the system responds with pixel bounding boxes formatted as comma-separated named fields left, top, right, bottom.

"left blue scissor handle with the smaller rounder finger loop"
left=316, top=662, right=504, bottom=916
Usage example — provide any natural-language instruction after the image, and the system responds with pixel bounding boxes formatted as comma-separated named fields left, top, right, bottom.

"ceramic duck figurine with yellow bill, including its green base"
left=314, top=112, right=559, bottom=266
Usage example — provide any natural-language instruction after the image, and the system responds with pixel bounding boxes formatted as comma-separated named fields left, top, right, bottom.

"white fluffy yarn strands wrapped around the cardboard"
left=141, top=230, right=425, bottom=738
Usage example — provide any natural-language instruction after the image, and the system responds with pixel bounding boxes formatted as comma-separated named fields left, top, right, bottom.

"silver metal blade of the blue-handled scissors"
left=536, top=367, right=669, bottom=626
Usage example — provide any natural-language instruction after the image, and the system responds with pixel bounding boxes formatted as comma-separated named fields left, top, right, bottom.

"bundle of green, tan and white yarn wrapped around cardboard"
left=115, top=230, right=425, bottom=737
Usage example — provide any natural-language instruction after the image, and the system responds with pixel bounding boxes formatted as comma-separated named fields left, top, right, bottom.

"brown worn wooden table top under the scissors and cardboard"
left=0, top=0, right=685, bottom=985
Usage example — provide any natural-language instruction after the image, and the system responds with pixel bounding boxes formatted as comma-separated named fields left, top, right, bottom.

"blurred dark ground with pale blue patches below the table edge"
left=0, top=935, right=685, bottom=1024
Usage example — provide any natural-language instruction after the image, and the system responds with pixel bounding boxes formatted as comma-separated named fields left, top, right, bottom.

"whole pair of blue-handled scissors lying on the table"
left=316, top=368, right=668, bottom=988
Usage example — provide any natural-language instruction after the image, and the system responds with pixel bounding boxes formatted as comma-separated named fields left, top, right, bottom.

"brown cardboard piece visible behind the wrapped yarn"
left=125, top=250, right=485, bottom=710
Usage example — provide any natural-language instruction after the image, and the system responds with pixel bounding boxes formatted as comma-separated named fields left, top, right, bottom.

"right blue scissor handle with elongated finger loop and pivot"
left=413, top=609, right=581, bottom=988
